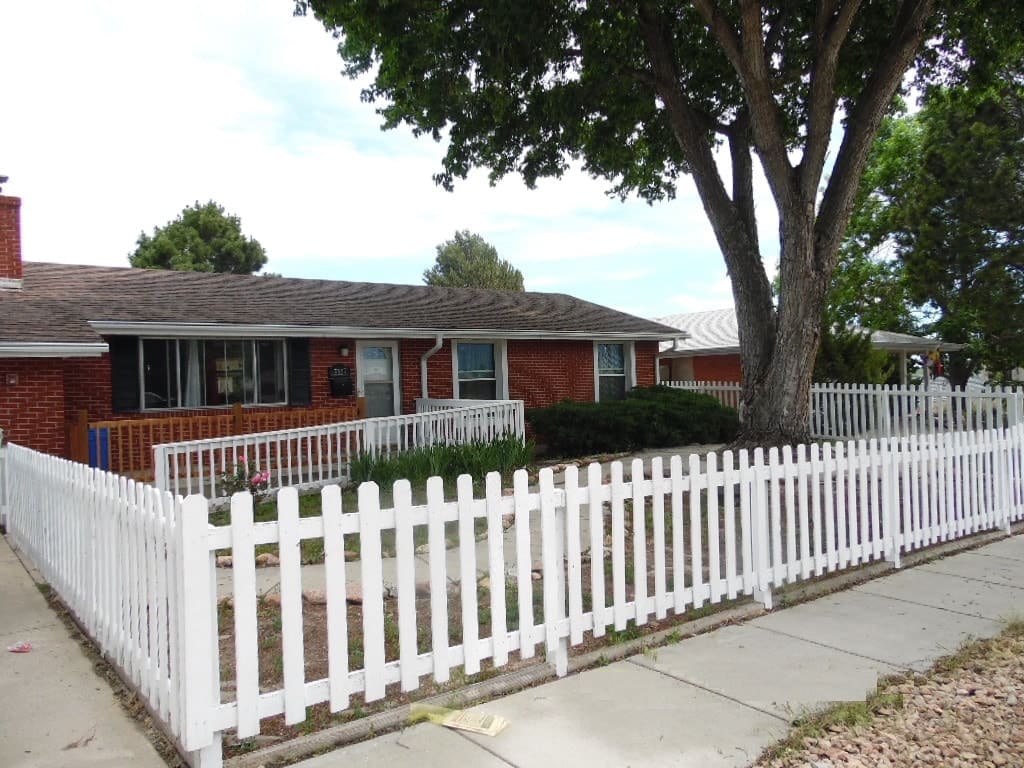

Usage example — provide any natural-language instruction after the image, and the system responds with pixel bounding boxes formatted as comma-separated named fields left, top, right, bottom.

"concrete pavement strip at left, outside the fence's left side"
left=0, top=537, right=167, bottom=768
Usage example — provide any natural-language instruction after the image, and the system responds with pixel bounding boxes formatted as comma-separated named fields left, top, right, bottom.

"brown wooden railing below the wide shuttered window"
left=68, top=403, right=357, bottom=480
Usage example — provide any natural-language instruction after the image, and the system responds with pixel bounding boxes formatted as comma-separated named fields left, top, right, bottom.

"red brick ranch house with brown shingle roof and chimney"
left=0, top=197, right=680, bottom=454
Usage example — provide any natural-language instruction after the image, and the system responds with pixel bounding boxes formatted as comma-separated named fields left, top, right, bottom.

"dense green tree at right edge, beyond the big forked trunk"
left=829, top=72, right=1024, bottom=383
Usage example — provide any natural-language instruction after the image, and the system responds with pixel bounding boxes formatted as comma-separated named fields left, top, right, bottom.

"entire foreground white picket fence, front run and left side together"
left=6, top=425, right=1024, bottom=768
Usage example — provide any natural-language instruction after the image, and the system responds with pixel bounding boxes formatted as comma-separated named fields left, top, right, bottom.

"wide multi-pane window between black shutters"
left=141, top=339, right=288, bottom=410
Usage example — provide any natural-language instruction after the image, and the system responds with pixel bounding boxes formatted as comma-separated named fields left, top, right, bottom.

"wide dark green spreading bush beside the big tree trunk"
left=526, top=386, right=739, bottom=456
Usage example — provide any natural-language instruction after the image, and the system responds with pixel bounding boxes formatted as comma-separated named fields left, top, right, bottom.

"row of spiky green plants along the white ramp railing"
left=349, top=435, right=534, bottom=486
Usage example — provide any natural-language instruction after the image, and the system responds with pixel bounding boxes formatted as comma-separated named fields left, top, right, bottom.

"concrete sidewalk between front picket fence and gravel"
left=284, top=536, right=1024, bottom=768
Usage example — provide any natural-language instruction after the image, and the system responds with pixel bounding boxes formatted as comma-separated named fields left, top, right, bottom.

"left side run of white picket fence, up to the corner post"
left=0, top=444, right=205, bottom=754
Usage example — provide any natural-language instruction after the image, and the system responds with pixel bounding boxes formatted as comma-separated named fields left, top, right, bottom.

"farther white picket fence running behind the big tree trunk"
left=662, top=381, right=1024, bottom=440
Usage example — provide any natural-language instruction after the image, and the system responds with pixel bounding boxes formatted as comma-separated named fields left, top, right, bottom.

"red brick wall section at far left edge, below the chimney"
left=0, top=357, right=66, bottom=455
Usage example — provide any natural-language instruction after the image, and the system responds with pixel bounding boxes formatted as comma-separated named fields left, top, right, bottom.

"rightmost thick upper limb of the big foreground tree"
left=814, top=0, right=935, bottom=269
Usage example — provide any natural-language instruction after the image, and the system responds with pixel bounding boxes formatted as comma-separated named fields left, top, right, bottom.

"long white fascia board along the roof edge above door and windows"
left=89, top=321, right=679, bottom=341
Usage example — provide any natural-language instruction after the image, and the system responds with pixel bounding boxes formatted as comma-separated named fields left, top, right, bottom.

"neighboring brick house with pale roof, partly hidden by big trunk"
left=655, top=308, right=961, bottom=384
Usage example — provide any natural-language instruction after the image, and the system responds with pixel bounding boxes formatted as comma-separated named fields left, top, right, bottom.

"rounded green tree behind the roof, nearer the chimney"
left=128, top=201, right=266, bottom=274
